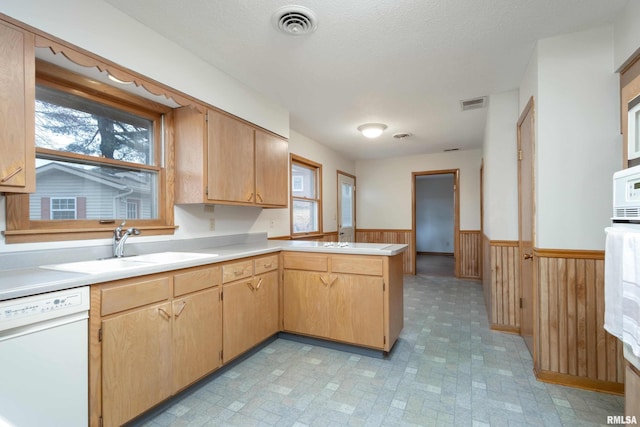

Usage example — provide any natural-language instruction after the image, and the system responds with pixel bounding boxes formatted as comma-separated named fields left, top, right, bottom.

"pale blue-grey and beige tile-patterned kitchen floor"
left=135, top=275, right=624, bottom=427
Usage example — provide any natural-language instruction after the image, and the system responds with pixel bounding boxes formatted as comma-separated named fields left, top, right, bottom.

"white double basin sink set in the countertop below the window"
left=41, top=252, right=218, bottom=274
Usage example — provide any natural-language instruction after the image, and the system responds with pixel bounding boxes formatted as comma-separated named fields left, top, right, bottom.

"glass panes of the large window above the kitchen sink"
left=29, top=85, right=159, bottom=220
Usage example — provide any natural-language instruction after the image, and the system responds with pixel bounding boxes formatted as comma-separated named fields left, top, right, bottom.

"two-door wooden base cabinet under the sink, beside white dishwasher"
left=89, top=266, right=222, bottom=427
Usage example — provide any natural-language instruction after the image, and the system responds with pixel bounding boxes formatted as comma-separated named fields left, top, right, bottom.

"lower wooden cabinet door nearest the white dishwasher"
left=102, top=302, right=171, bottom=426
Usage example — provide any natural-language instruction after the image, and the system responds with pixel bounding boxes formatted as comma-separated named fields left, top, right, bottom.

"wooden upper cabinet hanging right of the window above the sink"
left=174, top=107, right=289, bottom=207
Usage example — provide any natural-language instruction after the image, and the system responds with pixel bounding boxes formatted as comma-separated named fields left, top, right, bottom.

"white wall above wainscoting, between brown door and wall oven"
left=520, top=26, right=621, bottom=250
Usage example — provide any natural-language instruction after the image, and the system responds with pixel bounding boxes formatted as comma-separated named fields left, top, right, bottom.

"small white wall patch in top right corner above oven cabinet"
left=614, top=0, right=640, bottom=71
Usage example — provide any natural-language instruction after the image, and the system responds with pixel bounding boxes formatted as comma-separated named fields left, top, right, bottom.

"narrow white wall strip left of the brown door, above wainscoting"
left=483, top=90, right=519, bottom=240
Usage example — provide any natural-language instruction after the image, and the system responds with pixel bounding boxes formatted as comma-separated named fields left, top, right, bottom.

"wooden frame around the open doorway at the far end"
left=411, top=169, right=460, bottom=277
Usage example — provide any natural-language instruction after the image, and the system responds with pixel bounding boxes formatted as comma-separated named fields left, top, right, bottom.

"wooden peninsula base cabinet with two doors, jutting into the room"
left=283, top=252, right=403, bottom=351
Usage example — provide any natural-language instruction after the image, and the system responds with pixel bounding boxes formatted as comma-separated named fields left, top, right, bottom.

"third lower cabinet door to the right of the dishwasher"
left=222, top=278, right=256, bottom=363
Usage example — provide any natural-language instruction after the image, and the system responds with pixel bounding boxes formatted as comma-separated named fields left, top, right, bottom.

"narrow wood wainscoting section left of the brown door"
left=482, top=236, right=520, bottom=334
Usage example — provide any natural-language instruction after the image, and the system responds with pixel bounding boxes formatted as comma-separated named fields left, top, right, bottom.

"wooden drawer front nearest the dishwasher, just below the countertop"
left=101, top=277, right=171, bottom=316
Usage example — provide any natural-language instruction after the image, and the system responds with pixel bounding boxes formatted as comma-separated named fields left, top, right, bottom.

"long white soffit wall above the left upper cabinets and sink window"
left=0, top=0, right=289, bottom=137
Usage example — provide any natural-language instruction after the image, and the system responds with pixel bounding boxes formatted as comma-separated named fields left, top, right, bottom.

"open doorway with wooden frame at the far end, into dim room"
left=412, top=169, right=460, bottom=277
